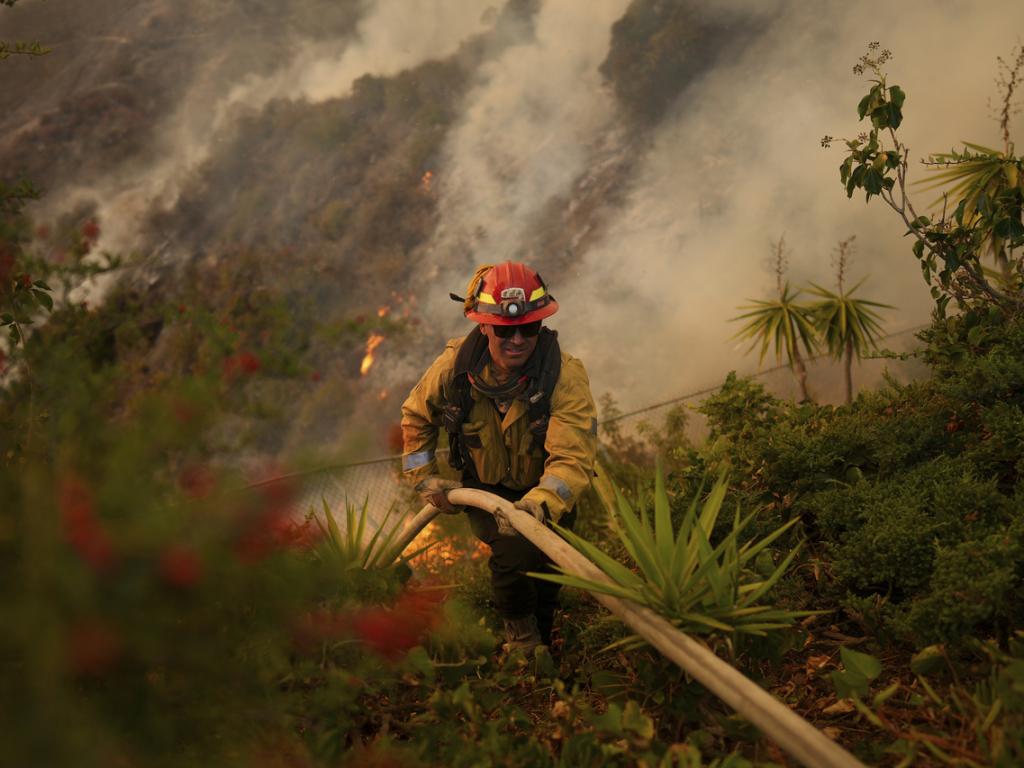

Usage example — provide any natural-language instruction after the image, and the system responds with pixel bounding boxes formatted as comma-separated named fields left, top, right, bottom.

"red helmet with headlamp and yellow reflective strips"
left=462, top=261, right=558, bottom=326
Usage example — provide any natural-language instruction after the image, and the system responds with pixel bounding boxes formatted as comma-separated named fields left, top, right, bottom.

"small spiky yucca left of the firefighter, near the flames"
left=309, top=499, right=433, bottom=570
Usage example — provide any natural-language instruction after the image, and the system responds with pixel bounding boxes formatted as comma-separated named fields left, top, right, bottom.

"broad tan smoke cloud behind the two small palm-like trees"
left=552, top=2, right=1024, bottom=409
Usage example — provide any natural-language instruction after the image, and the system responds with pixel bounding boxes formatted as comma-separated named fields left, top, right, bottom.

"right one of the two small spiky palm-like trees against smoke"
left=810, top=252, right=893, bottom=404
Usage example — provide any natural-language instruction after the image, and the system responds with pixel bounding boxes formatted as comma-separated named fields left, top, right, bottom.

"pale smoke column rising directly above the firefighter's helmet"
left=417, top=0, right=628, bottom=321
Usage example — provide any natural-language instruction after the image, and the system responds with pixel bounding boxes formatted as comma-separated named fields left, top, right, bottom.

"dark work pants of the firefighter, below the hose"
left=463, top=479, right=575, bottom=645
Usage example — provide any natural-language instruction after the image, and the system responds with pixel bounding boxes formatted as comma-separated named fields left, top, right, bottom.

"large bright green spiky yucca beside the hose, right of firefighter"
left=530, top=465, right=814, bottom=645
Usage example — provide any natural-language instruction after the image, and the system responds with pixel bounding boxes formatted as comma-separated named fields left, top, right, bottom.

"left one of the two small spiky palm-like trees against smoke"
left=732, top=282, right=817, bottom=400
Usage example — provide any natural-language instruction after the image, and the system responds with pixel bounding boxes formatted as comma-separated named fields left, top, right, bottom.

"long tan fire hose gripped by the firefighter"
left=391, top=488, right=864, bottom=768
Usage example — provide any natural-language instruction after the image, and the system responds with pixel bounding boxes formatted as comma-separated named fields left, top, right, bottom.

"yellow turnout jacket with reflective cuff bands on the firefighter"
left=401, top=339, right=597, bottom=521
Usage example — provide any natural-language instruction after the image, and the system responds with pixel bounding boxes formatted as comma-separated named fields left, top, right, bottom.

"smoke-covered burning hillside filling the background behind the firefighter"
left=0, top=0, right=1024, bottom=460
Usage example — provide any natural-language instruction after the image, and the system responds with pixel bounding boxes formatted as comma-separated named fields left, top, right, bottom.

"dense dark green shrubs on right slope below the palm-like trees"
left=694, top=309, right=1024, bottom=646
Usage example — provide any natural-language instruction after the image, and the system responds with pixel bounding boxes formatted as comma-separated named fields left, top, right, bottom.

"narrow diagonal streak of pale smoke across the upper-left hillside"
left=58, top=0, right=495, bottom=259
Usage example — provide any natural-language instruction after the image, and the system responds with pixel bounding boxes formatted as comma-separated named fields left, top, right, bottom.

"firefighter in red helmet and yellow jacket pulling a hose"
left=401, top=262, right=597, bottom=654
